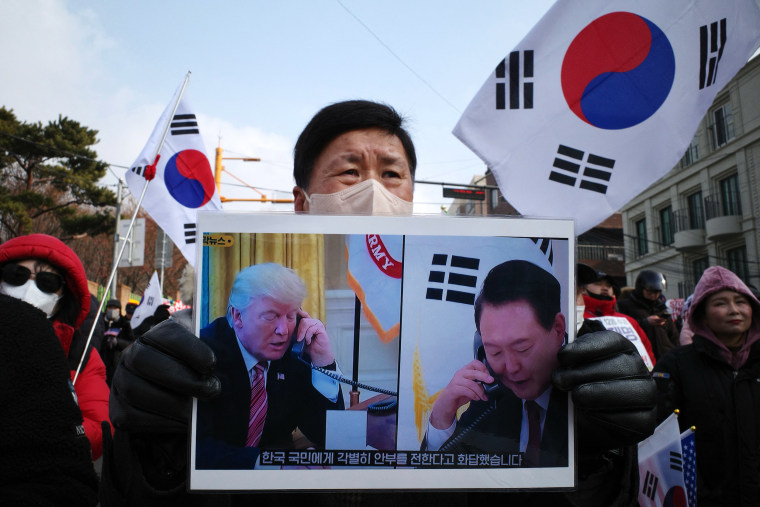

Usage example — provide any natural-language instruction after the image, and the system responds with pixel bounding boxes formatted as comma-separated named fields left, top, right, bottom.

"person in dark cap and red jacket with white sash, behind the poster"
left=576, top=263, right=655, bottom=371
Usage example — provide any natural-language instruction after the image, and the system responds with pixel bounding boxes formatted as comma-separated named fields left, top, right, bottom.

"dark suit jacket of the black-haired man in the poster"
left=423, top=388, right=568, bottom=467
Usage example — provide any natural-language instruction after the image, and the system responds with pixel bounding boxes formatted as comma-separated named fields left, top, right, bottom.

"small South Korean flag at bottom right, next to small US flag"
left=639, top=414, right=688, bottom=507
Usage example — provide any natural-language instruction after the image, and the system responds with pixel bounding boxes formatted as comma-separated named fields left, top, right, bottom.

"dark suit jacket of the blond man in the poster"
left=196, top=317, right=343, bottom=469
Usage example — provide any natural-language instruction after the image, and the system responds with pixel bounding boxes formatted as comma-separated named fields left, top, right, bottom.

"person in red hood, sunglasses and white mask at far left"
left=0, top=234, right=110, bottom=460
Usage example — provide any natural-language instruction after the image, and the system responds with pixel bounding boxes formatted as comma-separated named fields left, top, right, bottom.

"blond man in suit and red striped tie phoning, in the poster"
left=196, top=263, right=343, bottom=469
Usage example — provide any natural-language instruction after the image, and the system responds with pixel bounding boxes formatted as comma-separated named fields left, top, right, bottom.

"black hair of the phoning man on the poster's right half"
left=475, top=260, right=561, bottom=332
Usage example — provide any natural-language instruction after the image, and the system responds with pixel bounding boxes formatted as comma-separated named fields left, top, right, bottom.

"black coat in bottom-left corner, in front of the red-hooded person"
left=0, top=294, right=98, bottom=506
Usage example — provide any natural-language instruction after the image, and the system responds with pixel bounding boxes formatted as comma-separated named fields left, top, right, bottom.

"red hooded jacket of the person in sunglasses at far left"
left=0, top=234, right=109, bottom=459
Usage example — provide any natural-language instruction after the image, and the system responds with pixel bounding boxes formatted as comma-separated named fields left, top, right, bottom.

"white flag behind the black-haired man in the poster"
left=397, top=236, right=571, bottom=450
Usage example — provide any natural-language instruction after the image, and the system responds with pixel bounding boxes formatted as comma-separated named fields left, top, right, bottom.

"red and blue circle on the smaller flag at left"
left=164, top=150, right=216, bottom=208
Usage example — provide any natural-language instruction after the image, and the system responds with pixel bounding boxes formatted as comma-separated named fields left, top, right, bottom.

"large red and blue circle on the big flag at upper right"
left=561, top=12, right=676, bottom=130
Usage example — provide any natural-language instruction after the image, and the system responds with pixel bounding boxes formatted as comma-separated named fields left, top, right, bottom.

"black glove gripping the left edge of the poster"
left=110, top=320, right=221, bottom=433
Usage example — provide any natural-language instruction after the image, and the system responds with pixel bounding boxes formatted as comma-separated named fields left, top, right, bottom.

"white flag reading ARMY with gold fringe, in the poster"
left=346, top=234, right=403, bottom=342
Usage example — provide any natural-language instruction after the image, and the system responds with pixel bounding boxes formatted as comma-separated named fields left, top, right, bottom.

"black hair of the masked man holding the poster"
left=293, top=100, right=417, bottom=190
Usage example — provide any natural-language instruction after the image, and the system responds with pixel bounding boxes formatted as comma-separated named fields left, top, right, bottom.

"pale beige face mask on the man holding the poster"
left=303, top=179, right=412, bottom=215
